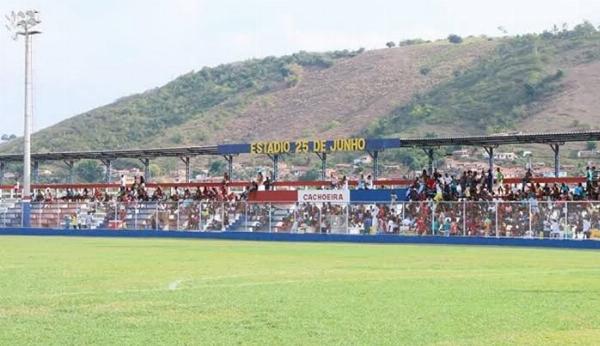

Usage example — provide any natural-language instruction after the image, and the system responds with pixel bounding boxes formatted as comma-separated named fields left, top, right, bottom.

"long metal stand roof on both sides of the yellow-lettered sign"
left=0, top=131, right=600, bottom=162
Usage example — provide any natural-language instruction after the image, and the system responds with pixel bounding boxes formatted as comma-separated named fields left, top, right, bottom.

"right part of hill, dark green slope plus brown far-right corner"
left=367, top=23, right=600, bottom=135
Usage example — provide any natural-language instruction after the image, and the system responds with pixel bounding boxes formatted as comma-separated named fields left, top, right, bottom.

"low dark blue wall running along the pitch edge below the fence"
left=0, top=228, right=600, bottom=249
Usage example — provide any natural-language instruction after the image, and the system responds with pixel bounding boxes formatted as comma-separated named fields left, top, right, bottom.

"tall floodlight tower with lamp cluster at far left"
left=5, top=10, right=41, bottom=201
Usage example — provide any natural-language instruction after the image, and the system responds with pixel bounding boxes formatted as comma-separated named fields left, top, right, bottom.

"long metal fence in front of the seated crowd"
left=0, top=200, right=600, bottom=239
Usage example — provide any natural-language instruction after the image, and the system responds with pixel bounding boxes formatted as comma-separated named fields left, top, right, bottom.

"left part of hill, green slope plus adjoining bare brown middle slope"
left=0, top=40, right=495, bottom=152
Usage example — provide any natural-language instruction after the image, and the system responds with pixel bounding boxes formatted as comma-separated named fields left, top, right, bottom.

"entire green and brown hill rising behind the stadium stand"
left=0, top=23, right=600, bottom=176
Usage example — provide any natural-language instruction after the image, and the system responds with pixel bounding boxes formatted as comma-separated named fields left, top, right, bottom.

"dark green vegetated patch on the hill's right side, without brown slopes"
left=367, top=23, right=600, bottom=136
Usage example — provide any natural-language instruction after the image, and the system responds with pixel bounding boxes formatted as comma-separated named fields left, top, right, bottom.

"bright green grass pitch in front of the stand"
left=0, top=236, right=600, bottom=345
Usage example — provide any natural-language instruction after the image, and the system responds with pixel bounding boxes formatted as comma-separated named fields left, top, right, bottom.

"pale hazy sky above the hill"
left=0, top=0, right=600, bottom=135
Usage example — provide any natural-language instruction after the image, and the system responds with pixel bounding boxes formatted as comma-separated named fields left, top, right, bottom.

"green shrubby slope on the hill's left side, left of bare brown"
left=0, top=50, right=362, bottom=152
